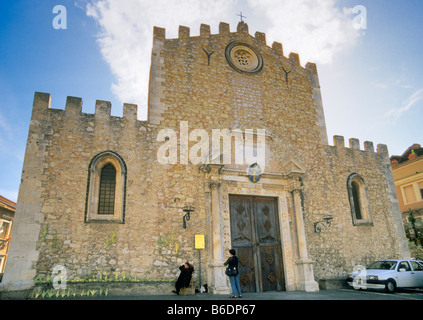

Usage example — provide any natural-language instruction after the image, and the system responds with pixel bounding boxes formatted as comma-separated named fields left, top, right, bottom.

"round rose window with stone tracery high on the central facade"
left=225, top=42, right=263, bottom=73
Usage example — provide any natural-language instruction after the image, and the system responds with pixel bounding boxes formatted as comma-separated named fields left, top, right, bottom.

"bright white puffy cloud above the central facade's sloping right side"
left=248, top=0, right=360, bottom=65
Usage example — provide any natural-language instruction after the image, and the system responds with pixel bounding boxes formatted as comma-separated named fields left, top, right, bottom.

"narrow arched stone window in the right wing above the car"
left=347, top=173, right=373, bottom=226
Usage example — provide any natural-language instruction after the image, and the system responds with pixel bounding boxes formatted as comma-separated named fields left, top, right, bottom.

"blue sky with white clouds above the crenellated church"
left=0, top=0, right=423, bottom=201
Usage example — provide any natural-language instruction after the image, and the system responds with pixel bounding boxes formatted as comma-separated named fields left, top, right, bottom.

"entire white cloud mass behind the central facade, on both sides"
left=87, top=0, right=358, bottom=118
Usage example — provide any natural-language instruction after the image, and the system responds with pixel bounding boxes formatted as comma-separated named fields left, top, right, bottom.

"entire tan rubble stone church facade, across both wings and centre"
left=0, top=23, right=408, bottom=290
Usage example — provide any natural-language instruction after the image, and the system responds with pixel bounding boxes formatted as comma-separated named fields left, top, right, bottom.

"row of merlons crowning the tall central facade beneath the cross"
left=153, top=21, right=317, bottom=74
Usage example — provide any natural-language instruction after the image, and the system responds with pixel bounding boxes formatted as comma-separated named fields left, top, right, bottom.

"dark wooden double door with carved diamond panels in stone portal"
left=229, top=195, right=285, bottom=292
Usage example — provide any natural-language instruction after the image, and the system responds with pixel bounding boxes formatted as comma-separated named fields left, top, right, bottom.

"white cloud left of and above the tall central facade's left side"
left=87, top=0, right=237, bottom=118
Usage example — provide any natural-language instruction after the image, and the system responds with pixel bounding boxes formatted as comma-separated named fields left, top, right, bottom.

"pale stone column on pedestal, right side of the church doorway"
left=291, top=182, right=319, bottom=292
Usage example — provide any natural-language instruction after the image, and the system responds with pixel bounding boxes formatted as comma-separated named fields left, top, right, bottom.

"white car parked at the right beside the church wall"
left=347, top=260, right=423, bottom=293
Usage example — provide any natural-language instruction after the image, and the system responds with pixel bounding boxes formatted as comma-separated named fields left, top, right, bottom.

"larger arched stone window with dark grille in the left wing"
left=85, top=151, right=126, bottom=223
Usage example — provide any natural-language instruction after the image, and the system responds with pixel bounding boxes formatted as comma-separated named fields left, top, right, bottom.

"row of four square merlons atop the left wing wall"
left=32, top=92, right=142, bottom=121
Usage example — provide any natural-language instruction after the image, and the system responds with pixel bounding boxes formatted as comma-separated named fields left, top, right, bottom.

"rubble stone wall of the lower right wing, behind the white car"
left=303, top=137, right=409, bottom=279
